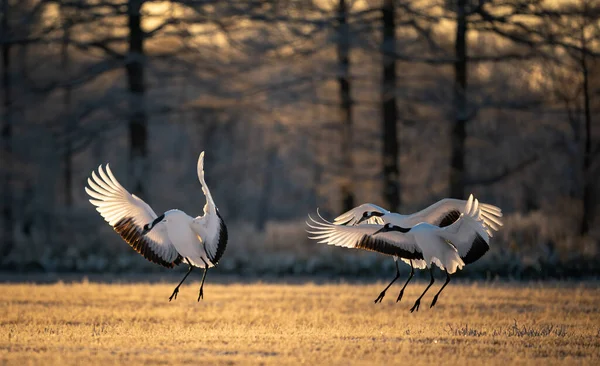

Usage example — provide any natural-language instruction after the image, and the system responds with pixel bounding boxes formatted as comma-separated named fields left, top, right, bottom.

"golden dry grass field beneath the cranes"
left=0, top=278, right=600, bottom=365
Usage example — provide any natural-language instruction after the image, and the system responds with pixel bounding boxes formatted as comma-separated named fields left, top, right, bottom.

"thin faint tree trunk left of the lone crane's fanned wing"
left=60, top=7, right=73, bottom=207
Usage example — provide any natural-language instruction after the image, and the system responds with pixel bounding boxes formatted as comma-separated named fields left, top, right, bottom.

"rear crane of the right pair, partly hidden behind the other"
left=334, top=194, right=502, bottom=303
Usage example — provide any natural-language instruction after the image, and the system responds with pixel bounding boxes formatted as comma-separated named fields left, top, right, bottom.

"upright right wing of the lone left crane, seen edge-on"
left=191, top=151, right=228, bottom=265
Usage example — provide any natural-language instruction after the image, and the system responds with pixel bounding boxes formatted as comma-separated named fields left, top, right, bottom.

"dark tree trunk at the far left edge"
left=0, top=0, right=14, bottom=257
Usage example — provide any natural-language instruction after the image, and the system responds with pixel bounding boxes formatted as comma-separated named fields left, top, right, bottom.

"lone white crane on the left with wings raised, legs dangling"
left=85, top=151, right=227, bottom=301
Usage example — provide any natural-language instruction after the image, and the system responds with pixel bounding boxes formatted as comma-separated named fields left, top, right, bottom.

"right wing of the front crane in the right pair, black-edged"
left=439, top=195, right=490, bottom=264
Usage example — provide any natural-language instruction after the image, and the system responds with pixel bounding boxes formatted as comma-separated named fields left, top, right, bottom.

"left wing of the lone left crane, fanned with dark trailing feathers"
left=85, top=164, right=181, bottom=268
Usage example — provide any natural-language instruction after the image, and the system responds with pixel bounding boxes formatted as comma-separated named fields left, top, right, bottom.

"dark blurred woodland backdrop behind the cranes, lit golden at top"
left=0, top=0, right=600, bottom=279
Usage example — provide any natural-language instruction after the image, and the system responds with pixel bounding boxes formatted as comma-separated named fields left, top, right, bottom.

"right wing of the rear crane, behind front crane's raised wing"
left=404, top=194, right=503, bottom=236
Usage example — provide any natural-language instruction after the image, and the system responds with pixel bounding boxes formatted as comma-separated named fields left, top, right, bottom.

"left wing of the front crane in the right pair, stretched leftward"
left=306, top=215, right=423, bottom=259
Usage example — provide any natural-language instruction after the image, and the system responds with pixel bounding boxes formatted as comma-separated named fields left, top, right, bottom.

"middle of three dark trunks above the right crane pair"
left=381, top=0, right=401, bottom=211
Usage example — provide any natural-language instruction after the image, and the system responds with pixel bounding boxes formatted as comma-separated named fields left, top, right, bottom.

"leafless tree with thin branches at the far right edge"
left=540, top=0, right=600, bottom=235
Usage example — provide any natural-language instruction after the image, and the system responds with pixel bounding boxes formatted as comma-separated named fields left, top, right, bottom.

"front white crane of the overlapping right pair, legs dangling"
left=307, top=197, right=489, bottom=312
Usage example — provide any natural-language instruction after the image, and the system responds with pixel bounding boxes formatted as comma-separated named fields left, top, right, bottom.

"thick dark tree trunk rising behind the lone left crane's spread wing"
left=126, top=0, right=148, bottom=195
